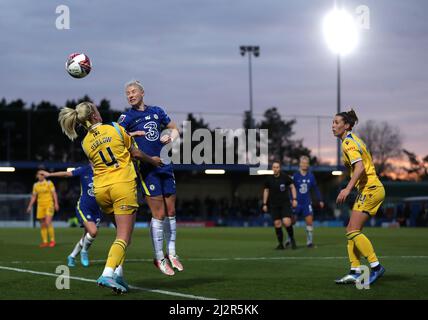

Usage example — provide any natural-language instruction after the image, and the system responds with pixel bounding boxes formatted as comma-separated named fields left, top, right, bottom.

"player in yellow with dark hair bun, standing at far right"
left=332, top=109, right=385, bottom=284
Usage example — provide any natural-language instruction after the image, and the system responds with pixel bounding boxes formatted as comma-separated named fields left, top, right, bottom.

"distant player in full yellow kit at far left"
left=27, top=170, right=59, bottom=248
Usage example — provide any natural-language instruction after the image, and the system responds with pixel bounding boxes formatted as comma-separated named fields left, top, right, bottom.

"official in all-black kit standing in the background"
left=263, top=161, right=297, bottom=249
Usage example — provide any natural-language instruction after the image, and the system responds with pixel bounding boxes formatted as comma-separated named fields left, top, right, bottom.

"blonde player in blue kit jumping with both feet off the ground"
left=118, top=81, right=183, bottom=276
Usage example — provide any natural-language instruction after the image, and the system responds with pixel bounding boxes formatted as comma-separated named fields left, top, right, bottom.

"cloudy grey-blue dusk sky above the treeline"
left=0, top=0, right=428, bottom=164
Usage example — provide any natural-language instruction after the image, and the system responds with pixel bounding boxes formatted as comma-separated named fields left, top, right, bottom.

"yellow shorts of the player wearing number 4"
left=94, top=180, right=138, bottom=214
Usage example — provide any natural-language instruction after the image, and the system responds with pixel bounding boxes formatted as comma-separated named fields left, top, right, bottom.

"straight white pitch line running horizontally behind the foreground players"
left=0, top=256, right=428, bottom=264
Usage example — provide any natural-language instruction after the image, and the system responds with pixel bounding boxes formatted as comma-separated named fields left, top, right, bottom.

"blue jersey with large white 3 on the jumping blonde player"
left=117, top=106, right=172, bottom=172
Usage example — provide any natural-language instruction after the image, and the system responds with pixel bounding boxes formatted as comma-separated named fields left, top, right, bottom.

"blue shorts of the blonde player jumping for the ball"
left=141, top=171, right=176, bottom=197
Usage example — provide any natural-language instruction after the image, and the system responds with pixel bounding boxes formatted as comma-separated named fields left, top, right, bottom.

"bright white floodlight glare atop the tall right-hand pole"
left=323, top=8, right=358, bottom=55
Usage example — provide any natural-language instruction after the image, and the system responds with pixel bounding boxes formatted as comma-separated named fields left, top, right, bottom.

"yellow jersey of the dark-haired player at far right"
left=342, top=132, right=382, bottom=191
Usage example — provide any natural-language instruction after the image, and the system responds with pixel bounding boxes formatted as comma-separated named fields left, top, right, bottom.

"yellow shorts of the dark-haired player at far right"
left=352, top=185, right=385, bottom=216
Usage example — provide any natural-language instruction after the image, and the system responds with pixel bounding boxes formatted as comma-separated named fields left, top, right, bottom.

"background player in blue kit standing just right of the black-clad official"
left=286, top=156, right=324, bottom=248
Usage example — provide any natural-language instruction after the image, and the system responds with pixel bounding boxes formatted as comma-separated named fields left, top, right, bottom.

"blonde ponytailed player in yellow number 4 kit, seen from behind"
left=58, top=102, right=161, bottom=293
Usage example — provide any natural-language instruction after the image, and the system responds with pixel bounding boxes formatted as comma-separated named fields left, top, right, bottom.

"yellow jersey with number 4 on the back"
left=82, top=122, right=137, bottom=187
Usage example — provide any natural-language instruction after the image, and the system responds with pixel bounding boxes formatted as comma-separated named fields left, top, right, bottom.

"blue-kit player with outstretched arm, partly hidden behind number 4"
left=41, top=165, right=101, bottom=267
